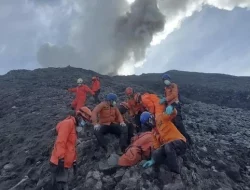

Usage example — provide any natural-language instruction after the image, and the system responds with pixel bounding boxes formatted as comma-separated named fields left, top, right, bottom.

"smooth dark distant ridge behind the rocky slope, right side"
left=114, top=71, right=250, bottom=109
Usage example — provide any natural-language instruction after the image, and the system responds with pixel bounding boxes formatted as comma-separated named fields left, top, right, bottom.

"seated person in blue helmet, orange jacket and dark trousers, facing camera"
left=92, top=93, right=128, bottom=153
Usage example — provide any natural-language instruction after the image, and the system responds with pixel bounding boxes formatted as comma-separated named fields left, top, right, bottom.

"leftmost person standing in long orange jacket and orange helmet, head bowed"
left=50, top=107, right=91, bottom=190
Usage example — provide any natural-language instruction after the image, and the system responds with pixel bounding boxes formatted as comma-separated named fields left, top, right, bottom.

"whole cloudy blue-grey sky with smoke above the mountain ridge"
left=0, top=0, right=250, bottom=76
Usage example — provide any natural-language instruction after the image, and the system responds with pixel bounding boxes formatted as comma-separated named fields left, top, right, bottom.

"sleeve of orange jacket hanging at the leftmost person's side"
left=55, top=123, right=72, bottom=159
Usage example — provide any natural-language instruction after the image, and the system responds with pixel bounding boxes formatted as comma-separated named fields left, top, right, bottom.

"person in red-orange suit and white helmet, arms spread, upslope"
left=68, top=78, right=94, bottom=112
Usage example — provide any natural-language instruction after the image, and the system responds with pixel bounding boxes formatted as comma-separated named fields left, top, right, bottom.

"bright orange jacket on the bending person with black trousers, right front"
left=152, top=110, right=186, bottom=149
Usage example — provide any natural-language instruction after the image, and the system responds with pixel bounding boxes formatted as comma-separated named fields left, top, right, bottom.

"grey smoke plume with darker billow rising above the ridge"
left=37, top=0, right=165, bottom=74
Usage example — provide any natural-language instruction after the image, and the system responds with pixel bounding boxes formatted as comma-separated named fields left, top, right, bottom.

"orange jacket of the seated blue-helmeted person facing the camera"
left=91, top=101, right=124, bottom=125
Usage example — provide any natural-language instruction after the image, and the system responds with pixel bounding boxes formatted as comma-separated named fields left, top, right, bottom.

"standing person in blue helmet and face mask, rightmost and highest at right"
left=159, top=74, right=192, bottom=145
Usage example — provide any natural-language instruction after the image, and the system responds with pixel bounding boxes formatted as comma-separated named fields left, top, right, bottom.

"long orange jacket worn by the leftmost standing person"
left=50, top=116, right=77, bottom=168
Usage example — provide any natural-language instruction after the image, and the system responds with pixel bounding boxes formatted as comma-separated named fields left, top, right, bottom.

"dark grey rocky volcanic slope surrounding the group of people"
left=0, top=67, right=250, bottom=190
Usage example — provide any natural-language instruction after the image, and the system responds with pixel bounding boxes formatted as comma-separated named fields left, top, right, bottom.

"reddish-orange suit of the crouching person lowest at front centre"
left=118, top=132, right=154, bottom=166
